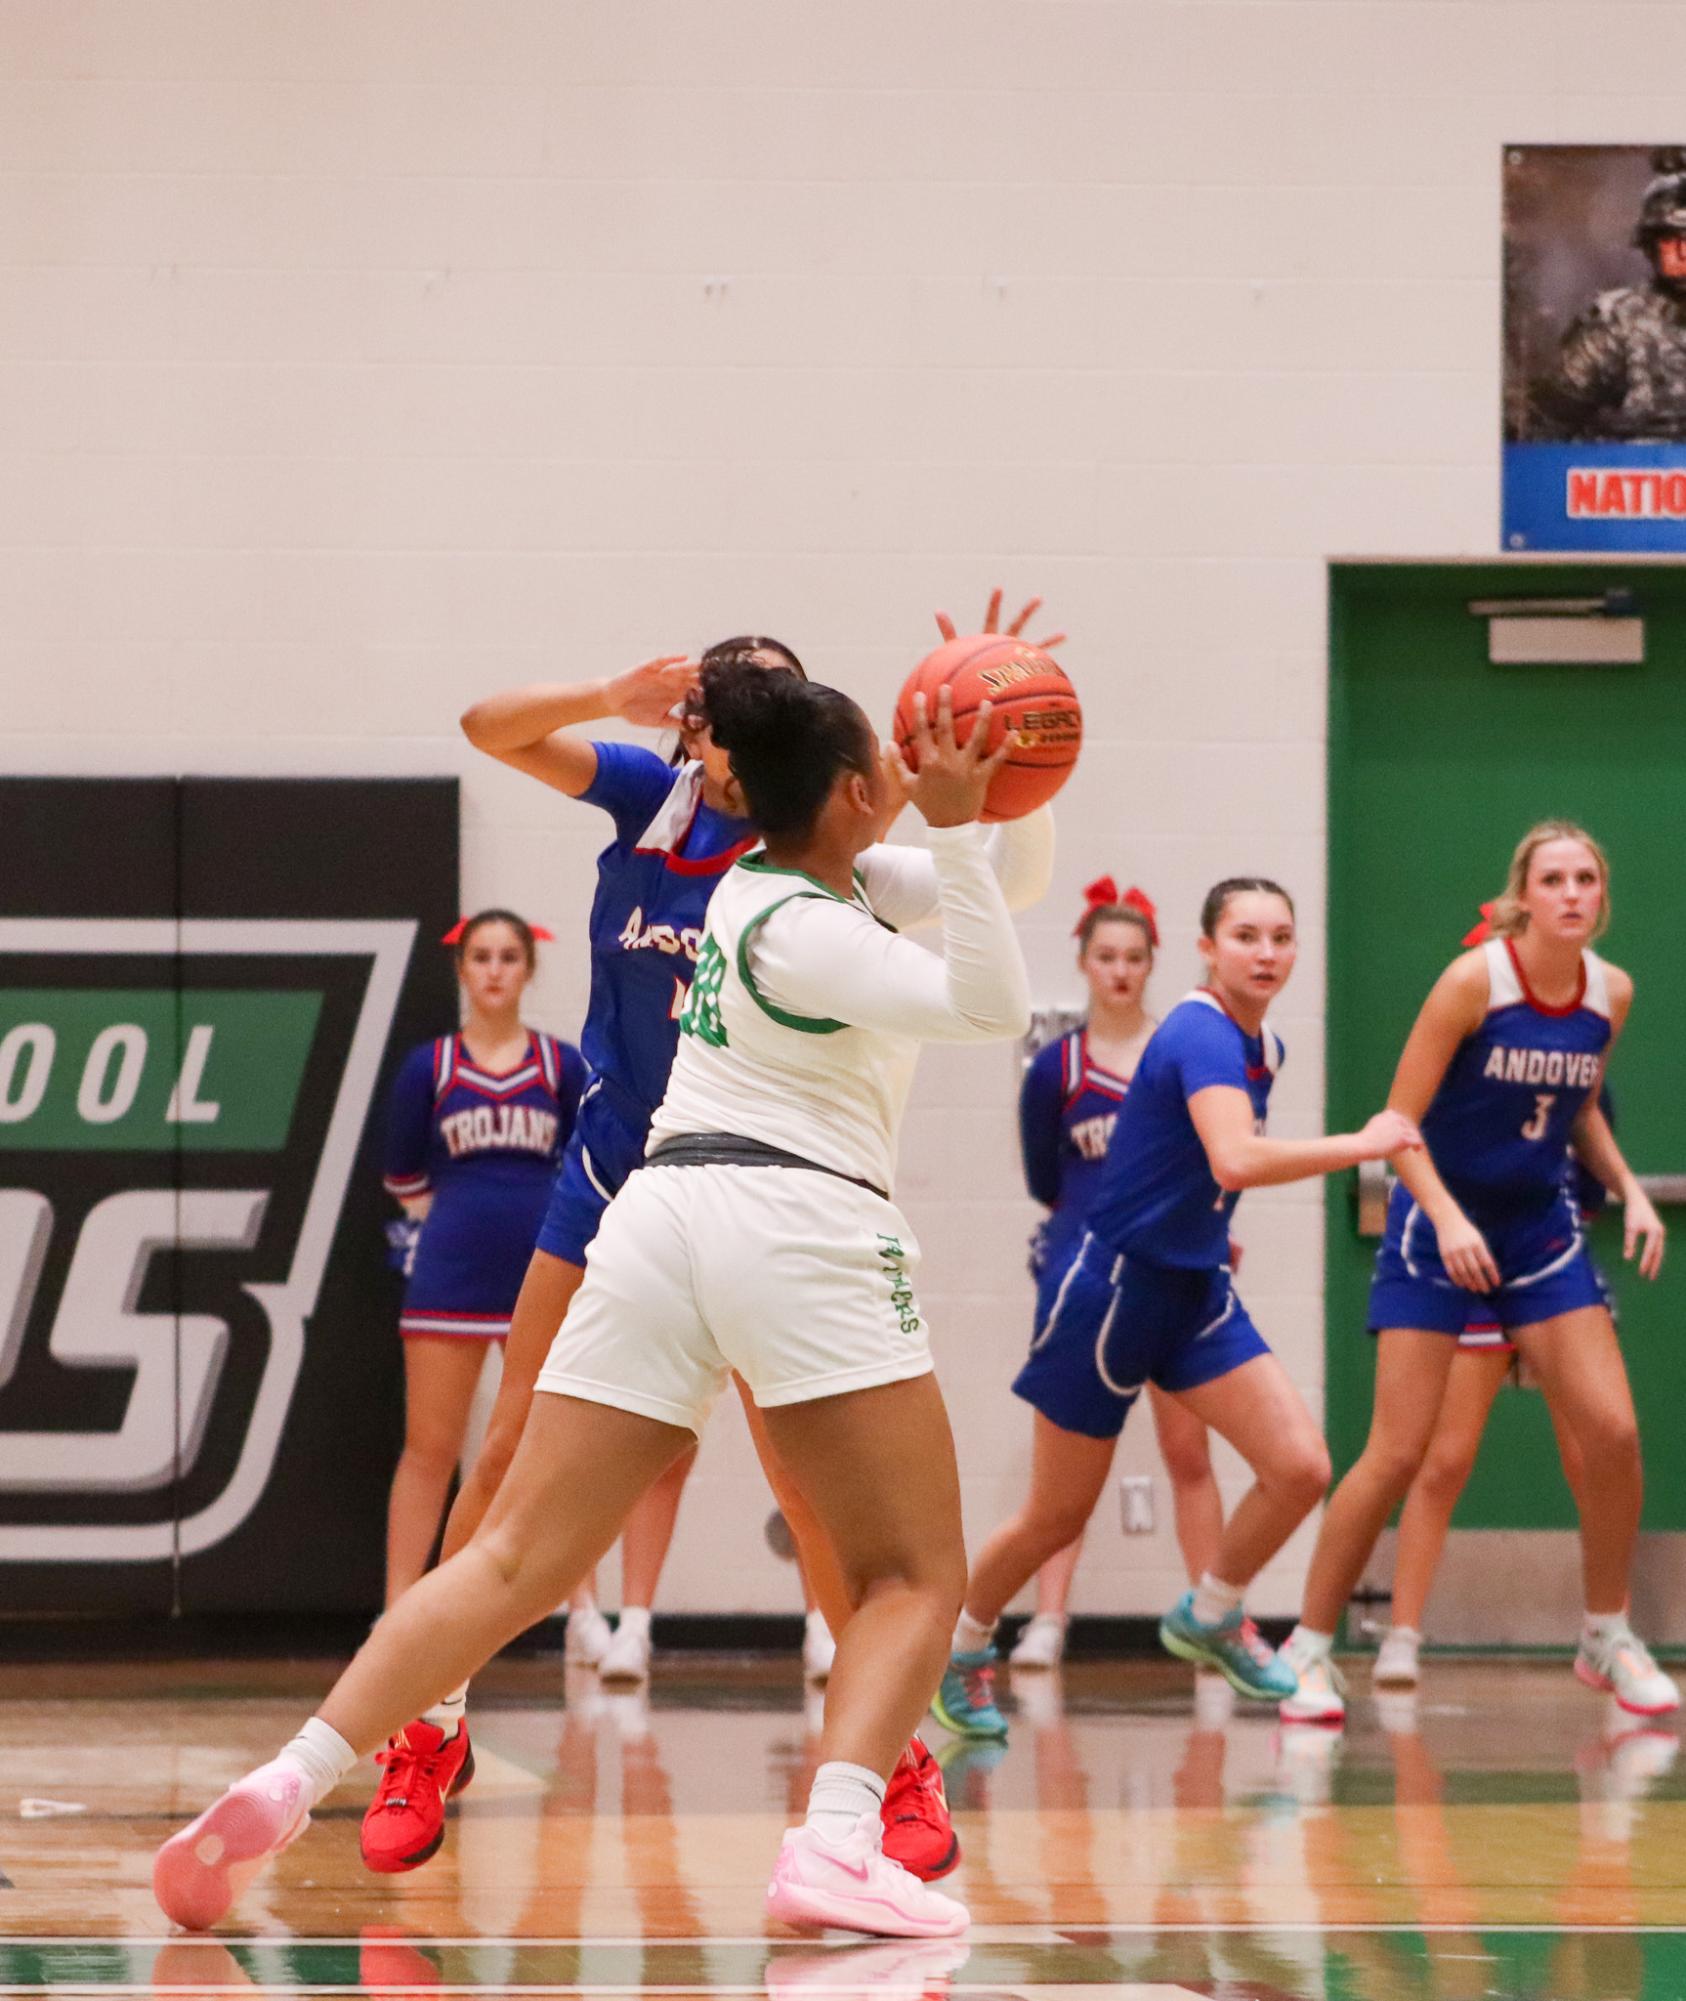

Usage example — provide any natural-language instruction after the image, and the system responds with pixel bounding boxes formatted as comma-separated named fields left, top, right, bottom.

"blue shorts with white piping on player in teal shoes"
left=1012, top=1237, right=1270, bottom=1439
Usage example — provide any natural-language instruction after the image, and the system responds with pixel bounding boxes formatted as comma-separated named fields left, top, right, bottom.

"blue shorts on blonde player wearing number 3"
left=1368, top=1187, right=1610, bottom=1339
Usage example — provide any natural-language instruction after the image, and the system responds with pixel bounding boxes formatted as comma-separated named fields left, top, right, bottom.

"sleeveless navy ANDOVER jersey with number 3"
left=1422, top=938, right=1610, bottom=1213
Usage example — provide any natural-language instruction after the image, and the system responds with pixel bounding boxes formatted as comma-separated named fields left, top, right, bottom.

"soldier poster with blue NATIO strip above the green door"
left=1502, top=146, right=1686, bottom=552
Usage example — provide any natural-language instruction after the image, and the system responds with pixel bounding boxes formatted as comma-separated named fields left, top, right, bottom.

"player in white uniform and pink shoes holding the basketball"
left=154, top=668, right=1052, bottom=1937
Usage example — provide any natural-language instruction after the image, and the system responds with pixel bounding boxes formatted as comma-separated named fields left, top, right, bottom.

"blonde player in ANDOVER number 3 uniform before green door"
left=1282, top=820, right=1680, bottom=1723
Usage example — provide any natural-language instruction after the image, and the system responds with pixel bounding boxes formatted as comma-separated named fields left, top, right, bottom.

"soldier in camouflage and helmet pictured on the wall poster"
left=1534, top=148, right=1686, bottom=442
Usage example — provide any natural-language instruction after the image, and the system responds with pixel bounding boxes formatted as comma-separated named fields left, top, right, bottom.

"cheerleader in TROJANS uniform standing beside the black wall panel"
left=386, top=910, right=584, bottom=1605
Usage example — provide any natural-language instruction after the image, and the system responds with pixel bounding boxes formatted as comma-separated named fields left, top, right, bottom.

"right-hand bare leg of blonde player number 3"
left=1514, top=1307, right=1644, bottom=1615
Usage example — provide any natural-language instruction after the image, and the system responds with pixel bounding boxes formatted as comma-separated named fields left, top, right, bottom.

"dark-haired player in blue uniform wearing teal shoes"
left=936, top=876, right=1420, bottom=1737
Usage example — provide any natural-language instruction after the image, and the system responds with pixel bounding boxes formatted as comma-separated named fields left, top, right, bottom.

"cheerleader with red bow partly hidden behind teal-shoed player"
left=1010, top=876, right=1224, bottom=1669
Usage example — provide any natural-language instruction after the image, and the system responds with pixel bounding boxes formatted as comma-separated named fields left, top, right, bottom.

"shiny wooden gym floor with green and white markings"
left=0, top=1655, right=1686, bottom=2001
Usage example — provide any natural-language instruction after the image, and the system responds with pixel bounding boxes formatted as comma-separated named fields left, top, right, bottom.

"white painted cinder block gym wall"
left=0, top=0, right=1664, bottom=1613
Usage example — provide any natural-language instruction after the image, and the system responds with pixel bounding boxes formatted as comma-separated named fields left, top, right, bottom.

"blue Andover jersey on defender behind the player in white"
left=580, top=744, right=758, bottom=1125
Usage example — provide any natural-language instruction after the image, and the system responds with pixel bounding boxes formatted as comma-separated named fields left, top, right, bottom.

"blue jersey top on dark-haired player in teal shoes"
left=1088, top=986, right=1282, bottom=1269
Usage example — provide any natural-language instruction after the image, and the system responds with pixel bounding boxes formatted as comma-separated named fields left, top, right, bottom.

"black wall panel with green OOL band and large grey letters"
left=0, top=778, right=458, bottom=1613
